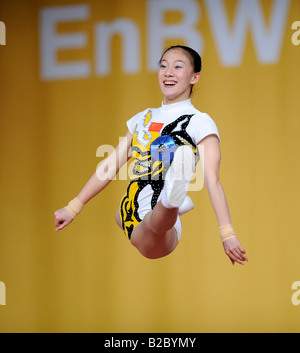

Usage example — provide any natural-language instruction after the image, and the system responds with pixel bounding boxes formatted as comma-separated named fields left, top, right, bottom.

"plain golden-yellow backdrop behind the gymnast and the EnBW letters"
left=0, top=0, right=300, bottom=332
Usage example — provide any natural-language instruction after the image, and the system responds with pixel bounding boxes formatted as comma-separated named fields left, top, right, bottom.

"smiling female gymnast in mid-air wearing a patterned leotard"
left=54, top=45, right=248, bottom=265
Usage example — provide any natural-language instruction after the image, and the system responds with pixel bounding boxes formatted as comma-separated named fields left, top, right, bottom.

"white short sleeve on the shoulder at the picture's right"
left=187, top=113, right=221, bottom=145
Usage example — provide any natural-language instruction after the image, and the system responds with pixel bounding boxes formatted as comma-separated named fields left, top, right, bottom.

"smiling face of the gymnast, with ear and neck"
left=158, top=48, right=200, bottom=104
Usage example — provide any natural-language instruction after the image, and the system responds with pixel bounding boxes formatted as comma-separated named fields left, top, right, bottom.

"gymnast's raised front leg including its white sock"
left=118, top=146, right=195, bottom=259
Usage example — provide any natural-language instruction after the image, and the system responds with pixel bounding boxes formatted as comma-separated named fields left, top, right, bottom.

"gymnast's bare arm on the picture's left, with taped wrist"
left=54, top=131, right=132, bottom=232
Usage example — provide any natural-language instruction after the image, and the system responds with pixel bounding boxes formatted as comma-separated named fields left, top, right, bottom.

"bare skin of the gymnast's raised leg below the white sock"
left=131, top=202, right=178, bottom=259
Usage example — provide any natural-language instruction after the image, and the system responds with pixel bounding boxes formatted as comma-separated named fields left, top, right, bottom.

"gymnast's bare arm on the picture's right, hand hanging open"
left=198, top=135, right=248, bottom=265
